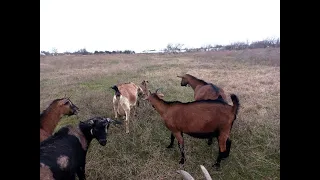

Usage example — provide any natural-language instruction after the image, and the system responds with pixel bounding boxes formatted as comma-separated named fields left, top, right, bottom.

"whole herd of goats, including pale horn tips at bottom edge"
left=40, top=74, right=240, bottom=180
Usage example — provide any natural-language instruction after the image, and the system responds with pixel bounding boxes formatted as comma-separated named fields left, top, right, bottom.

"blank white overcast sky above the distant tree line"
left=40, top=0, right=280, bottom=52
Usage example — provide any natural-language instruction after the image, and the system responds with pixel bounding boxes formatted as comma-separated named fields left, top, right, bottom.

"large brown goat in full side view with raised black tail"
left=147, top=90, right=239, bottom=168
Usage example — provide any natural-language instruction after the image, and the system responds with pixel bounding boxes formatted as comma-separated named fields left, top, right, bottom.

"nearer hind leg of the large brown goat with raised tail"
left=213, top=135, right=231, bottom=170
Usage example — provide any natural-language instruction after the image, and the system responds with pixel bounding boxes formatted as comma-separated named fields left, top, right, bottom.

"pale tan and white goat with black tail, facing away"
left=111, top=81, right=148, bottom=133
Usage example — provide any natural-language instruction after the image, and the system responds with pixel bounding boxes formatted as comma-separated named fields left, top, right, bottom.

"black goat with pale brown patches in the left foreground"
left=40, top=117, right=121, bottom=180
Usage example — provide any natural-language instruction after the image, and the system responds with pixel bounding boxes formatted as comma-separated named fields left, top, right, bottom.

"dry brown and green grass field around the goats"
left=40, top=48, right=280, bottom=180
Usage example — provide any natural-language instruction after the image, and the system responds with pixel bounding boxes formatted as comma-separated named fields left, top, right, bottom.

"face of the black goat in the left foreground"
left=85, top=117, right=121, bottom=146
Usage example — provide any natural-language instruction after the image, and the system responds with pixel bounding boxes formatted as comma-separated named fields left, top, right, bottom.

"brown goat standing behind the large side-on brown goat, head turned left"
left=177, top=74, right=227, bottom=101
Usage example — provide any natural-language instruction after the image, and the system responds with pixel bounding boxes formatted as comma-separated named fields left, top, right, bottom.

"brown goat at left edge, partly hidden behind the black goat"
left=40, top=98, right=79, bottom=142
